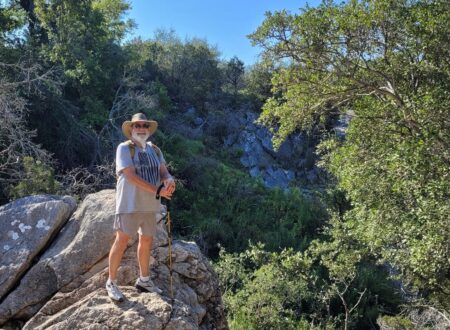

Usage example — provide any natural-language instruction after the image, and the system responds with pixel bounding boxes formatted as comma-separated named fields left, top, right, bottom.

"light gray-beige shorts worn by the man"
left=114, top=212, right=157, bottom=236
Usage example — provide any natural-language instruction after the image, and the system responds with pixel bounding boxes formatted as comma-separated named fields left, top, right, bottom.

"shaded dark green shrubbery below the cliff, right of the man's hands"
left=175, top=156, right=326, bottom=257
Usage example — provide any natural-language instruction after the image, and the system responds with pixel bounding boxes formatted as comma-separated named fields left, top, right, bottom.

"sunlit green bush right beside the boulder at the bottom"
left=215, top=244, right=331, bottom=330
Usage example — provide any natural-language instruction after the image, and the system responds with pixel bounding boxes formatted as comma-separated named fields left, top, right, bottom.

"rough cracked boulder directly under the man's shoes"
left=23, top=237, right=227, bottom=329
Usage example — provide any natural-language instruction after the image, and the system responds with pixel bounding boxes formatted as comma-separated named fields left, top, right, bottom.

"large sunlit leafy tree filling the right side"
left=251, top=0, right=450, bottom=308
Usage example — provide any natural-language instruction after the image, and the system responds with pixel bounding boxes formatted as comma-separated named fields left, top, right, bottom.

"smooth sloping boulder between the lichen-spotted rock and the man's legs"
left=0, top=190, right=115, bottom=324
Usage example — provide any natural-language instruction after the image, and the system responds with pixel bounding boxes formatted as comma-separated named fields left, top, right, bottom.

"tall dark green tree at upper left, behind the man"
left=5, top=0, right=132, bottom=169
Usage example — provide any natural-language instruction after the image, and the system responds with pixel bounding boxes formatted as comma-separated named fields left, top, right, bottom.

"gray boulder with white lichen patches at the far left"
left=0, top=196, right=76, bottom=301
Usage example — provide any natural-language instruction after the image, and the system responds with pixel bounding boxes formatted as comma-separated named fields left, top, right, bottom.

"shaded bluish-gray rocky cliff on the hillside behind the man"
left=179, top=106, right=349, bottom=189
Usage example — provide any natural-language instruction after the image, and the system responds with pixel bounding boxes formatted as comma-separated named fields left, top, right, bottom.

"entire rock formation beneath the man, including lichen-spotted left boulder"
left=0, top=190, right=227, bottom=329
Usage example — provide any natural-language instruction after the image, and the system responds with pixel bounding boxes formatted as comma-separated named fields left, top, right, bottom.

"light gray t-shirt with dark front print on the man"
left=116, top=142, right=166, bottom=214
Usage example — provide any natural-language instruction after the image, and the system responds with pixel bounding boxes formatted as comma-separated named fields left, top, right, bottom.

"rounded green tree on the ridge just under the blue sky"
left=130, top=30, right=221, bottom=111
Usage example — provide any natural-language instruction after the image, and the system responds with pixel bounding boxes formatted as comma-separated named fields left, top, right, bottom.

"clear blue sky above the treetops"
left=128, top=0, right=321, bottom=65
